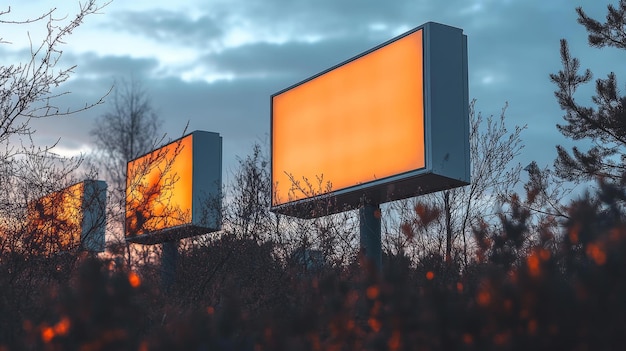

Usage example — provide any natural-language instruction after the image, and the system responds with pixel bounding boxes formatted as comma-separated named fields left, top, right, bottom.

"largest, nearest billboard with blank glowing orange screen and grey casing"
left=271, top=23, right=470, bottom=217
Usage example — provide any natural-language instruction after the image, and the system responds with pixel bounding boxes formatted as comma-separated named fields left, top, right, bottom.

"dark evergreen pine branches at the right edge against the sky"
left=550, top=0, right=626, bottom=183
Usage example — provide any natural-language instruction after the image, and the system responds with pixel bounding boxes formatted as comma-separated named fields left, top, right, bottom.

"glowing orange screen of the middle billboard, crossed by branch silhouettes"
left=126, top=135, right=193, bottom=236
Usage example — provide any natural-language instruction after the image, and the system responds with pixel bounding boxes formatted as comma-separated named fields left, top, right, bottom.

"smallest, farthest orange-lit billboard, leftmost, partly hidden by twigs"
left=28, top=180, right=107, bottom=254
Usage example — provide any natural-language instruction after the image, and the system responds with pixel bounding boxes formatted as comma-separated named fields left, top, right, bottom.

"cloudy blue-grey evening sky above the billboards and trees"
left=0, top=0, right=626, bottom=187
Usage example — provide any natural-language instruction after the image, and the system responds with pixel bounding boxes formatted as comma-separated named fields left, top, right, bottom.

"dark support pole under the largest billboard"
left=359, top=203, right=382, bottom=271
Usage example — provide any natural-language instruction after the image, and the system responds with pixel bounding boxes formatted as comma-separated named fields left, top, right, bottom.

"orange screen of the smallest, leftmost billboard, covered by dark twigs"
left=28, top=183, right=84, bottom=253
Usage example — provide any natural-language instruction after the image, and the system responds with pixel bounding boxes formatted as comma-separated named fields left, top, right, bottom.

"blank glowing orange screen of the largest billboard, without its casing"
left=272, top=30, right=425, bottom=206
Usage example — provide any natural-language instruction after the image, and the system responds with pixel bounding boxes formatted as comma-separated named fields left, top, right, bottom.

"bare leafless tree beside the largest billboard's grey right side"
left=392, top=100, right=525, bottom=265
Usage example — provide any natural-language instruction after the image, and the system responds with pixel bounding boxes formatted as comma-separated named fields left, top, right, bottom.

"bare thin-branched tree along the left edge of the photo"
left=0, top=0, right=106, bottom=253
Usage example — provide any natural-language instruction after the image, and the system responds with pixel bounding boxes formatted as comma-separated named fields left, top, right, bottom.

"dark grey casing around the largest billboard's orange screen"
left=270, top=22, right=470, bottom=218
